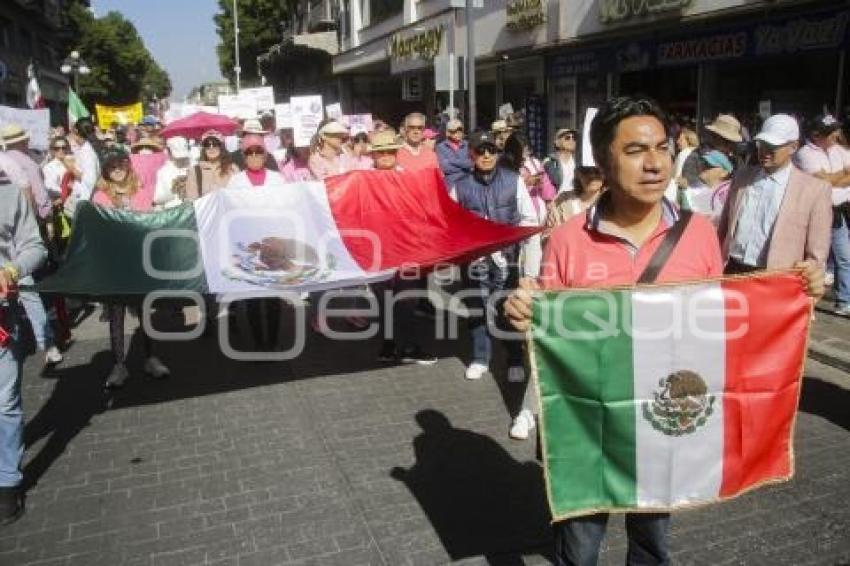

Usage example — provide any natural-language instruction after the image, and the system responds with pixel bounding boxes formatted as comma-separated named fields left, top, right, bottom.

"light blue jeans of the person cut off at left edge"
left=0, top=306, right=24, bottom=487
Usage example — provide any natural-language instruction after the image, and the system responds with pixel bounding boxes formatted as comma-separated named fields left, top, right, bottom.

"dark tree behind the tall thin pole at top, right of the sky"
left=213, top=0, right=285, bottom=84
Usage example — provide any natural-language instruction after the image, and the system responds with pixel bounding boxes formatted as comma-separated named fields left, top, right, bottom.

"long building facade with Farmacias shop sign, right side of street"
left=332, top=0, right=850, bottom=151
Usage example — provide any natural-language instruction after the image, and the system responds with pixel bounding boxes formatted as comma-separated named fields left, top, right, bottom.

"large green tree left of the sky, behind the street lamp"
left=63, top=3, right=171, bottom=105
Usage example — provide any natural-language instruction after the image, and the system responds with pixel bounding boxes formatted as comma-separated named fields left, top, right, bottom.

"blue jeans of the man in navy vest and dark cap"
left=463, top=256, right=522, bottom=367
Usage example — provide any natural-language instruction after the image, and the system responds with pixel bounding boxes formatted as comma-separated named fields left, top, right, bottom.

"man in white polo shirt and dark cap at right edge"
left=796, top=114, right=850, bottom=316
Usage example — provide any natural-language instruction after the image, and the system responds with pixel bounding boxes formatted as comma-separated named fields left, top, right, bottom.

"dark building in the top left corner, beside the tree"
left=0, top=0, right=80, bottom=122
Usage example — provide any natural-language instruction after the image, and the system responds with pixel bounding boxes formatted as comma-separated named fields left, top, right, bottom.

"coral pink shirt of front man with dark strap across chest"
left=539, top=202, right=723, bottom=289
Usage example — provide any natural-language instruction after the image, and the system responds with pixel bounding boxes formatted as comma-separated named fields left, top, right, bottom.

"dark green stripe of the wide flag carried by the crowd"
left=36, top=202, right=207, bottom=296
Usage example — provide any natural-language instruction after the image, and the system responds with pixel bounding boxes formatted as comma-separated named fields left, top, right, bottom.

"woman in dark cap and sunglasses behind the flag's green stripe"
left=92, top=149, right=171, bottom=389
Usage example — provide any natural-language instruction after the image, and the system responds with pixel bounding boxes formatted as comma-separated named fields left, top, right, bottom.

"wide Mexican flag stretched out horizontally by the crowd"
left=36, top=169, right=539, bottom=297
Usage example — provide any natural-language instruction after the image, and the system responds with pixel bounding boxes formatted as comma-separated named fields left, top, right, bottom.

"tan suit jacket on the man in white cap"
left=717, top=165, right=832, bottom=269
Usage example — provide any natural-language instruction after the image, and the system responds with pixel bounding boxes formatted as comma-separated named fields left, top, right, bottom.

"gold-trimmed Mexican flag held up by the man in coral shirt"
left=529, top=273, right=811, bottom=520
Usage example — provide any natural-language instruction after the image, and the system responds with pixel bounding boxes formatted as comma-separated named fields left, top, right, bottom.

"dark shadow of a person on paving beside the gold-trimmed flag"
left=390, top=409, right=551, bottom=565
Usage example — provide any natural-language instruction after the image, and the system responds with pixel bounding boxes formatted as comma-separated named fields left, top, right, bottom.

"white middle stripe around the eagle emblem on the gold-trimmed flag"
left=632, top=283, right=726, bottom=507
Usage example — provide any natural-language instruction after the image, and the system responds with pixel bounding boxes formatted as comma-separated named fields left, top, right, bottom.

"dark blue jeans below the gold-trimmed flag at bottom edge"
left=554, top=513, right=670, bottom=566
